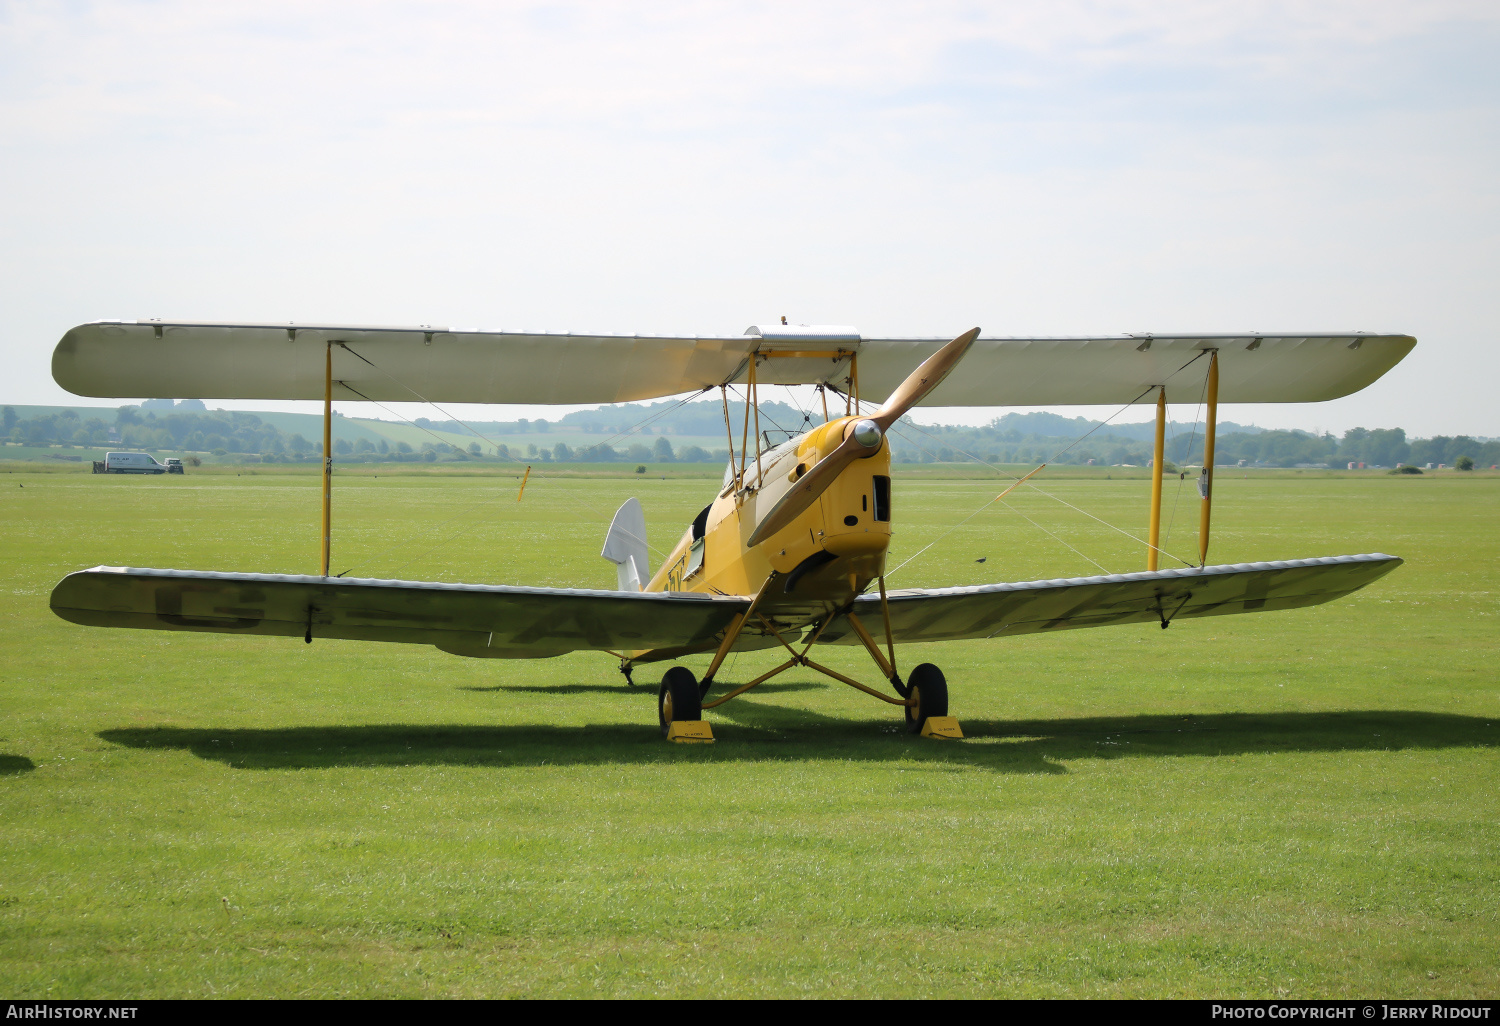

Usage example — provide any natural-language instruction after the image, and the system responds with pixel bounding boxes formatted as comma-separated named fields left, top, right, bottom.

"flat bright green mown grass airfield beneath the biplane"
left=0, top=467, right=1500, bottom=998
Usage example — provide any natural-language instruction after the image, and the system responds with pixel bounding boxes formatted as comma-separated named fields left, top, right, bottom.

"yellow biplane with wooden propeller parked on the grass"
left=51, top=318, right=1416, bottom=741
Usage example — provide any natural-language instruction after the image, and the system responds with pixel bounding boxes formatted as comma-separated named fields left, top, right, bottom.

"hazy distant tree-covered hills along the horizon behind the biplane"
left=0, top=399, right=1500, bottom=467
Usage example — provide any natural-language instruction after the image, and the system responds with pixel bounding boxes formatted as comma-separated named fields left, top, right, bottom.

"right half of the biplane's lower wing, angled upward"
left=825, top=554, right=1401, bottom=645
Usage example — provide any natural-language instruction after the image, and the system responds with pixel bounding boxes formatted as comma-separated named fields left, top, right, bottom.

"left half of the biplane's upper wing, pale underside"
left=53, top=321, right=750, bottom=404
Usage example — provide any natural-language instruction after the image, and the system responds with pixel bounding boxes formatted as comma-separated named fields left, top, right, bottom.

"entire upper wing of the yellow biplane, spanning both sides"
left=53, top=321, right=1416, bottom=407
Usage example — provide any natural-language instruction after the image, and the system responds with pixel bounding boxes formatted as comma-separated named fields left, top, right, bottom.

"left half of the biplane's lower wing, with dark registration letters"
left=53, top=567, right=750, bottom=659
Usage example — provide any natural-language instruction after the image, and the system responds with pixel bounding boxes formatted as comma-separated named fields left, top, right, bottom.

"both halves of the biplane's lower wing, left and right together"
left=51, top=554, right=1401, bottom=659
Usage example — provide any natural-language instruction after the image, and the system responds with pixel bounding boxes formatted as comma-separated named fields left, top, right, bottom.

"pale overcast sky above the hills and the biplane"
left=0, top=0, right=1500, bottom=435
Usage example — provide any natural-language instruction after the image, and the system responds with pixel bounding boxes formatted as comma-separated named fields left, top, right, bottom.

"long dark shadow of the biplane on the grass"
left=99, top=701, right=1500, bottom=774
